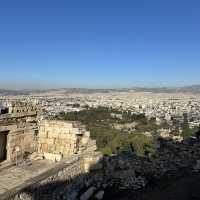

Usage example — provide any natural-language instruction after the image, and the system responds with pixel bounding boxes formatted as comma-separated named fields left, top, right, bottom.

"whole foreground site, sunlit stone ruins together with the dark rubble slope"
left=0, top=100, right=200, bottom=200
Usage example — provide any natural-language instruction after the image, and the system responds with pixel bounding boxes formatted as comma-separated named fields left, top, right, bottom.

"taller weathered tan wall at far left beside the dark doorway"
left=0, top=102, right=38, bottom=163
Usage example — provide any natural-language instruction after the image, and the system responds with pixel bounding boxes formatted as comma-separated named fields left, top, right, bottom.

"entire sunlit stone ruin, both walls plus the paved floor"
left=0, top=101, right=101, bottom=199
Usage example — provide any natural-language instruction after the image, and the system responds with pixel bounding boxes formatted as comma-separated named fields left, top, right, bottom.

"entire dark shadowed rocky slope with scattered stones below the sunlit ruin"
left=16, top=138, right=200, bottom=200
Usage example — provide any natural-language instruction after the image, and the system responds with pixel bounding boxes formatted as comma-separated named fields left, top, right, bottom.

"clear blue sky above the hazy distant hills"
left=0, top=0, right=200, bottom=88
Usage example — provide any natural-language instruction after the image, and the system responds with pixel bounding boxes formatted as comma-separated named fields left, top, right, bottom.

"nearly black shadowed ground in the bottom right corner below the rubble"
left=104, top=174, right=200, bottom=200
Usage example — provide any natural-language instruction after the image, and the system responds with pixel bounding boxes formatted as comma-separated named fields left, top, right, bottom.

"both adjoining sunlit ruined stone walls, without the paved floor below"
left=0, top=102, right=101, bottom=166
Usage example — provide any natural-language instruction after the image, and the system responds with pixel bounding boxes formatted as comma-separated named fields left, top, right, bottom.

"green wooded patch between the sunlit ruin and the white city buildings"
left=55, top=107, right=158, bottom=156
